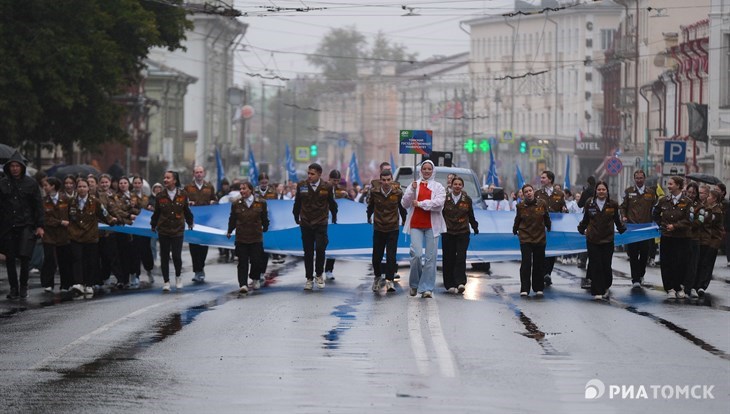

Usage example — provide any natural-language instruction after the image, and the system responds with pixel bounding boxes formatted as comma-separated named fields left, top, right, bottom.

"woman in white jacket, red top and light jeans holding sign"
left=401, top=160, right=446, bottom=298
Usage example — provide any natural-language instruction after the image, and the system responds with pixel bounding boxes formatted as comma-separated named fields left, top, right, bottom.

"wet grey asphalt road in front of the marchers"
left=0, top=249, right=730, bottom=413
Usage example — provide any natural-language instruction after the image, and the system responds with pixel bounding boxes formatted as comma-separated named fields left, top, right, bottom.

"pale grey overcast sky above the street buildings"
left=234, top=0, right=513, bottom=83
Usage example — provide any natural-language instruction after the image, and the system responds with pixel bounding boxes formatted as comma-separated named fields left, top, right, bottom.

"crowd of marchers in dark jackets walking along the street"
left=0, top=149, right=729, bottom=299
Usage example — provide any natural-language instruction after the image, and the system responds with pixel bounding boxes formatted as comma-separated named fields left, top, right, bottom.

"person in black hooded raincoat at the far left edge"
left=0, top=151, right=44, bottom=299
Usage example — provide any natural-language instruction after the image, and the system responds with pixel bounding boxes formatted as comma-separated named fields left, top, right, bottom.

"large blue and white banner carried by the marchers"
left=100, top=199, right=659, bottom=262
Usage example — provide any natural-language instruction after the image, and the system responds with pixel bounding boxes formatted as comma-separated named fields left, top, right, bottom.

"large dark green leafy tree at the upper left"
left=0, top=0, right=192, bottom=160
